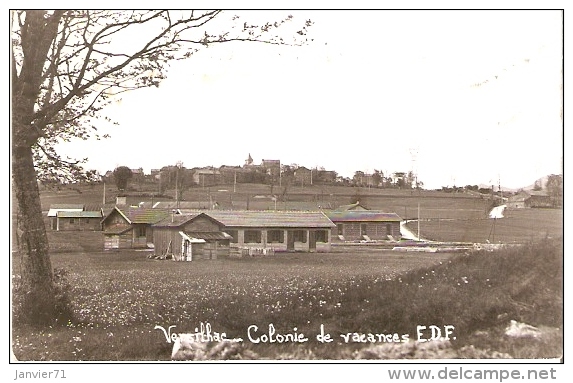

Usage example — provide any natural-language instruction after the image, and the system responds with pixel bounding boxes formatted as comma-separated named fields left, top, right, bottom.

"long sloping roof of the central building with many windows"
left=205, top=210, right=335, bottom=228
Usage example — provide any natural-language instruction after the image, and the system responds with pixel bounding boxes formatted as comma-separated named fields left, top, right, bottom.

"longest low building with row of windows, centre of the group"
left=183, top=210, right=336, bottom=252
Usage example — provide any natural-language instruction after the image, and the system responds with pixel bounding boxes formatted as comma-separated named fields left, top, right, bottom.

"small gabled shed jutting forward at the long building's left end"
left=153, top=212, right=232, bottom=261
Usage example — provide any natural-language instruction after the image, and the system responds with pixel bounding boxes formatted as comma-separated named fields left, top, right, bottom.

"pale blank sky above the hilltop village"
left=53, top=10, right=563, bottom=188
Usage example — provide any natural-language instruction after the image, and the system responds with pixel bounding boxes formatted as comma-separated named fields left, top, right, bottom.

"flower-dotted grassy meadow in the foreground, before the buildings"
left=13, top=241, right=563, bottom=361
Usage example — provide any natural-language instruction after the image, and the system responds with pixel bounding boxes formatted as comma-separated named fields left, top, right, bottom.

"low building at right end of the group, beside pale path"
left=327, top=210, right=402, bottom=241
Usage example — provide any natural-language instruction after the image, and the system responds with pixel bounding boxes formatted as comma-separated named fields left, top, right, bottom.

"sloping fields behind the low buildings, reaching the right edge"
left=31, top=180, right=563, bottom=243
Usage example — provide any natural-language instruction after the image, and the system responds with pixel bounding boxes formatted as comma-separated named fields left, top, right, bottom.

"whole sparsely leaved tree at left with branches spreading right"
left=11, top=10, right=312, bottom=323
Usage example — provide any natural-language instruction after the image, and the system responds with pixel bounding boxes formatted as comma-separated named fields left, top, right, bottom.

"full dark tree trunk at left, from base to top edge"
left=11, top=10, right=64, bottom=324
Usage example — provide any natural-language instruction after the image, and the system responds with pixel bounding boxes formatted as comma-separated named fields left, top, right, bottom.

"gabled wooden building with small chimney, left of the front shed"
left=101, top=206, right=169, bottom=250
